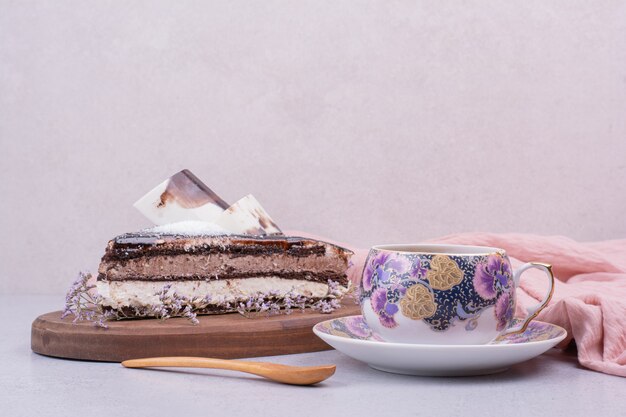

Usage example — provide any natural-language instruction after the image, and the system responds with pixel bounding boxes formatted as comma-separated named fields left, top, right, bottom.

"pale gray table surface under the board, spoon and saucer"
left=0, top=295, right=626, bottom=417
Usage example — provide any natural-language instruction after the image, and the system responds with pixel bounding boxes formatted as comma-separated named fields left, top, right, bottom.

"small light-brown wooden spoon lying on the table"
left=122, top=356, right=336, bottom=385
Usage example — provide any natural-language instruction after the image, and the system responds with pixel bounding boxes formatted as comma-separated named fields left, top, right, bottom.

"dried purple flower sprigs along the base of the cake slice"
left=62, top=272, right=346, bottom=328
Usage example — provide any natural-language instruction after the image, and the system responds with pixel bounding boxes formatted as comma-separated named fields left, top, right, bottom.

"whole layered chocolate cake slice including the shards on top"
left=80, top=170, right=352, bottom=321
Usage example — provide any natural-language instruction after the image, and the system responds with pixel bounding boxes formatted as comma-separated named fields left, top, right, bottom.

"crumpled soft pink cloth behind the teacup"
left=288, top=232, right=626, bottom=377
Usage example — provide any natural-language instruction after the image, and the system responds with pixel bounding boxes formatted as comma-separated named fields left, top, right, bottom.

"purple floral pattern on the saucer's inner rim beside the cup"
left=315, top=316, right=564, bottom=345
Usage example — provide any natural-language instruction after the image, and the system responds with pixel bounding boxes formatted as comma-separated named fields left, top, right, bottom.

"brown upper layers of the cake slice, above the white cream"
left=98, top=232, right=352, bottom=285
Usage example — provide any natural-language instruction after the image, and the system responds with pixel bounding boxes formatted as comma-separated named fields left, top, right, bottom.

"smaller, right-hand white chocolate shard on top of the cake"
left=215, top=194, right=282, bottom=235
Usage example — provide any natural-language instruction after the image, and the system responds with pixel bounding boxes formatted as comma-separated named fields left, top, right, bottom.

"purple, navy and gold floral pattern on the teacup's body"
left=360, top=251, right=515, bottom=331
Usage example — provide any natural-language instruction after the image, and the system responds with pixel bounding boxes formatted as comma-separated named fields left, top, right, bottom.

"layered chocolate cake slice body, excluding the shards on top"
left=97, top=228, right=352, bottom=317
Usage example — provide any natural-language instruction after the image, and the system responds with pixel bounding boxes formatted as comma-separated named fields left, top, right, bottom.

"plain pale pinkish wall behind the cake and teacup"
left=0, top=0, right=626, bottom=293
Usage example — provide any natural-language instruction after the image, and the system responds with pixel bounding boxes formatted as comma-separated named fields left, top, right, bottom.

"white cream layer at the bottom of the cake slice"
left=96, top=276, right=347, bottom=309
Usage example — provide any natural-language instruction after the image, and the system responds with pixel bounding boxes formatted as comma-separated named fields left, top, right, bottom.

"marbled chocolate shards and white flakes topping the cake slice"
left=134, top=169, right=282, bottom=236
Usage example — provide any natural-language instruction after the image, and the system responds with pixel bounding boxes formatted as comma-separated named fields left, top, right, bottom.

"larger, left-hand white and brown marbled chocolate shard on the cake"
left=133, top=169, right=228, bottom=226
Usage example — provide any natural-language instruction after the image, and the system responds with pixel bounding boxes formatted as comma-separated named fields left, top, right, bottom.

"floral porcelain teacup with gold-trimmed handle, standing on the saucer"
left=360, top=244, right=554, bottom=345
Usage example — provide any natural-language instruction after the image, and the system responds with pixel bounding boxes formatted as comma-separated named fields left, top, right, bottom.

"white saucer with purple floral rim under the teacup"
left=313, top=316, right=567, bottom=376
